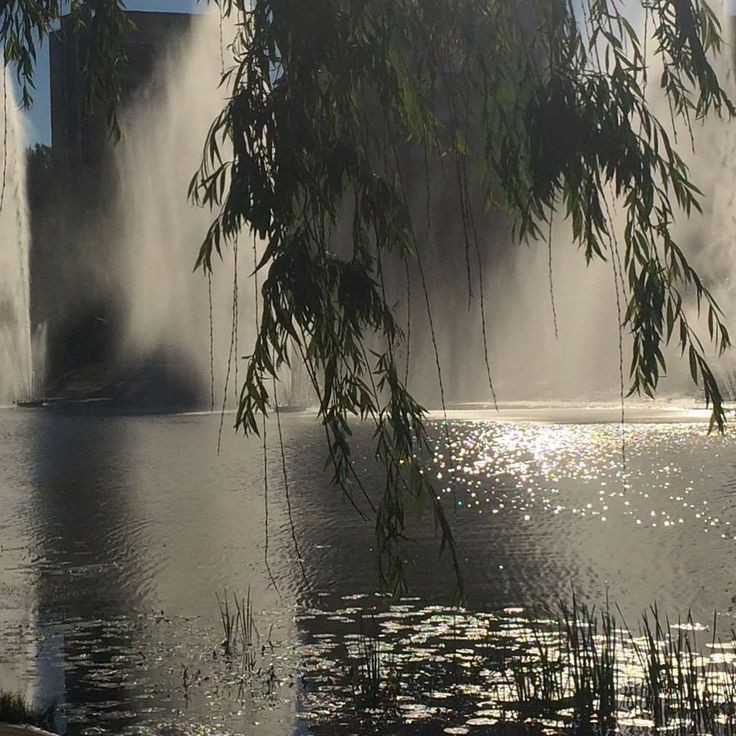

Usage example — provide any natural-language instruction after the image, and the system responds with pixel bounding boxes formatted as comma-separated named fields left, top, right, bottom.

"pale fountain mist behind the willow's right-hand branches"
left=438, top=2, right=736, bottom=402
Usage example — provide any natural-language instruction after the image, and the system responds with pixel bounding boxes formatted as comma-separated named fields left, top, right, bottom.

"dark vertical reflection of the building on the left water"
left=28, top=412, right=145, bottom=734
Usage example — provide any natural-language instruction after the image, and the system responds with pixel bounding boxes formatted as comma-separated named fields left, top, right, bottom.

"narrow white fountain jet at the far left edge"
left=0, top=68, right=33, bottom=405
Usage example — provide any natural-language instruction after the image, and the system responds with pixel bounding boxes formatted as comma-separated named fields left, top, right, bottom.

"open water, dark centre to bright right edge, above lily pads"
left=286, top=421, right=736, bottom=619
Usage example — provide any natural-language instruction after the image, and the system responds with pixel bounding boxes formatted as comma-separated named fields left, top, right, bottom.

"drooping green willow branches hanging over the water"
left=2, top=0, right=734, bottom=590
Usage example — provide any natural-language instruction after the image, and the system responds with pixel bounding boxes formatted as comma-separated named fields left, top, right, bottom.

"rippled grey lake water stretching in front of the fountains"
left=0, top=407, right=736, bottom=736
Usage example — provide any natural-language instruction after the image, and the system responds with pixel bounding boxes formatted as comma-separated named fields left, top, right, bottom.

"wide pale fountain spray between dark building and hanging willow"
left=115, top=14, right=253, bottom=408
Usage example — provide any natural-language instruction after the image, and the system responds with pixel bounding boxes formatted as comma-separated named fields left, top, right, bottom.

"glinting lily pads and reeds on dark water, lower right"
left=300, top=597, right=736, bottom=736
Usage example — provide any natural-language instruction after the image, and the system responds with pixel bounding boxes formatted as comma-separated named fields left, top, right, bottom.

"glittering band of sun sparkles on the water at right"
left=428, top=421, right=736, bottom=540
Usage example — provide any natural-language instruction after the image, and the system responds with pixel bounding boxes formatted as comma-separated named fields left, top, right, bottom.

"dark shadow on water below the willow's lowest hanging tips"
left=274, top=422, right=588, bottom=608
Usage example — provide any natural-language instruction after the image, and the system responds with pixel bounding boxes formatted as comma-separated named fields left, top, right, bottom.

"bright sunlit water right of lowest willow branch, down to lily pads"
left=426, top=422, right=736, bottom=619
